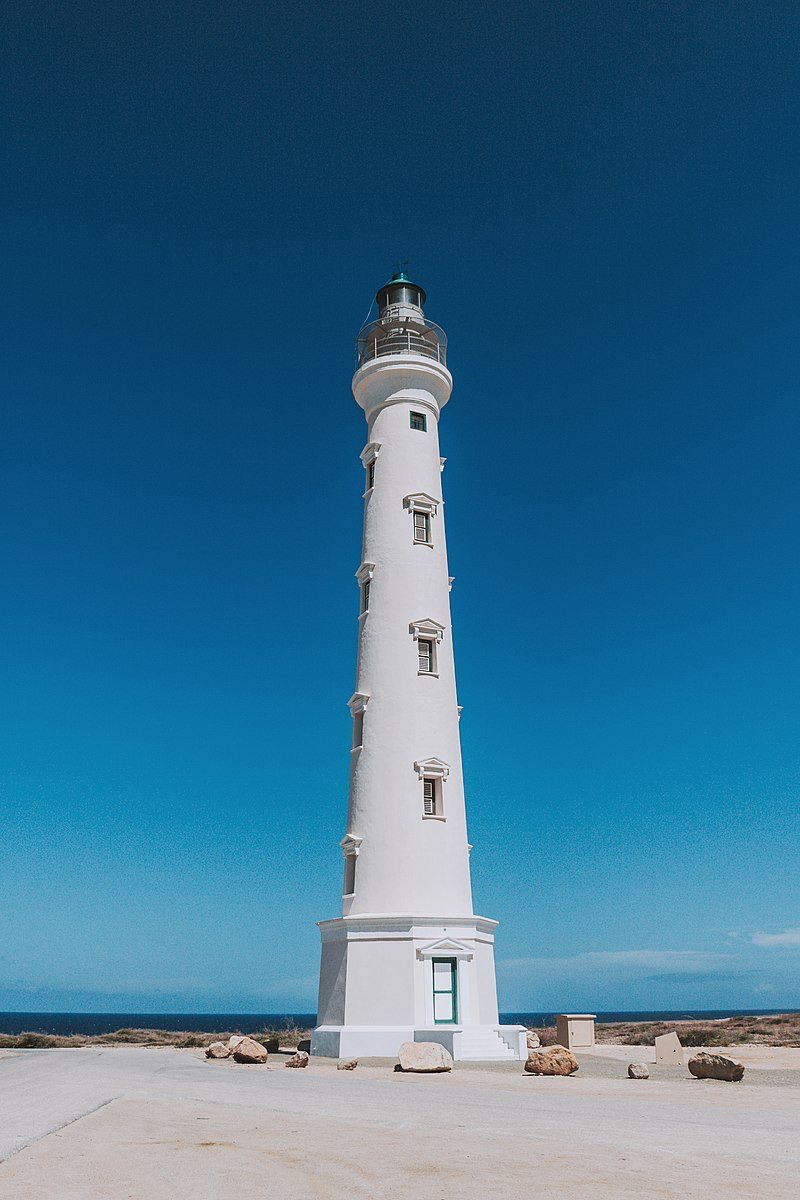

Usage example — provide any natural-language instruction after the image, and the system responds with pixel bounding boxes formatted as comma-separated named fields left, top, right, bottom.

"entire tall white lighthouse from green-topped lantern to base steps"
left=312, top=271, right=527, bottom=1060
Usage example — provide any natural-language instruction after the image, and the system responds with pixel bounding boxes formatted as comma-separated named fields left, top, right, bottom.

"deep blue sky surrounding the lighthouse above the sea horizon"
left=0, top=0, right=800, bottom=1012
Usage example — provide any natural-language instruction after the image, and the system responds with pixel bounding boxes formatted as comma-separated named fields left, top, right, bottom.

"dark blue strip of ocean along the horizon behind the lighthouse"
left=0, top=1008, right=800, bottom=1037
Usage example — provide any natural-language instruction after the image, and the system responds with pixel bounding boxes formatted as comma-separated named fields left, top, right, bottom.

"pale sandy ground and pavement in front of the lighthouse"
left=0, top=1046, right=800, bottom=1200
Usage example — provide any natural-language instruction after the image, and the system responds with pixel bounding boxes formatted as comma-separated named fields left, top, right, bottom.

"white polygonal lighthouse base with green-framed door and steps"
left=312, top=914, right=528, bottom=1062
